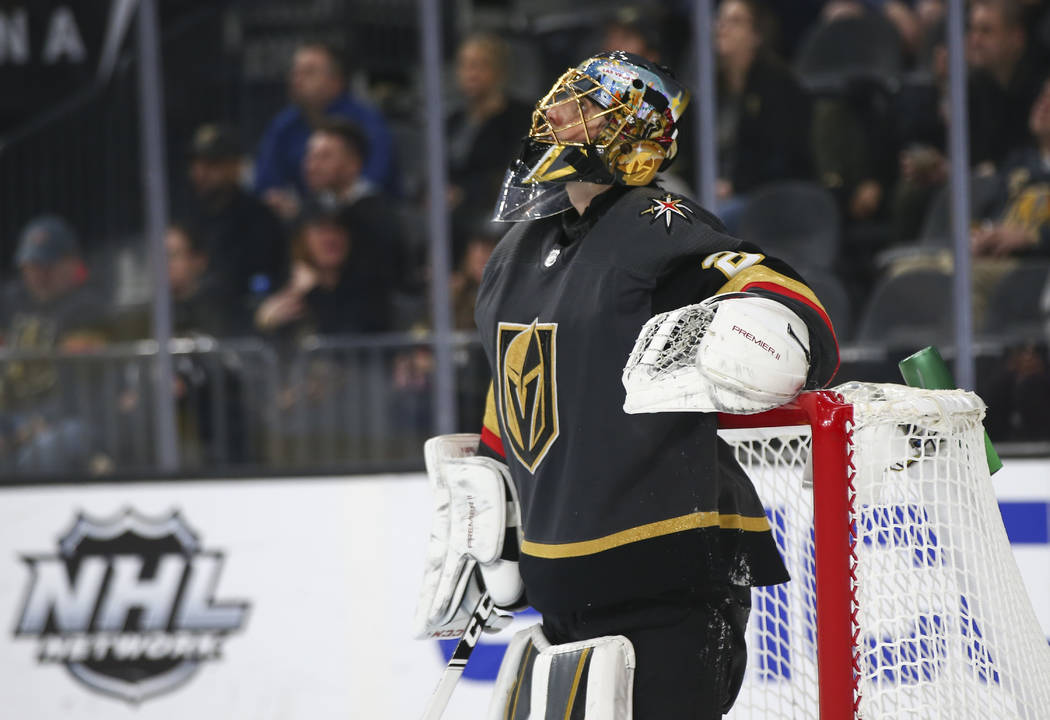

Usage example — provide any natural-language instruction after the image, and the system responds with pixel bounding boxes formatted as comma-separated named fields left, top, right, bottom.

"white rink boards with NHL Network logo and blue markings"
left=0, top=460, right=1050, bottom=720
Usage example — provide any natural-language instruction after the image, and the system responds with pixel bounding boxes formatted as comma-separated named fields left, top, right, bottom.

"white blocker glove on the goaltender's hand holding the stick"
left=415, top=433, right=524, bottom=638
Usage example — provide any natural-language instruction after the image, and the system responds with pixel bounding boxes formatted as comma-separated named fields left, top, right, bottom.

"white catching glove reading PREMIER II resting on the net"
left=623, top=293, right=810, bottom=415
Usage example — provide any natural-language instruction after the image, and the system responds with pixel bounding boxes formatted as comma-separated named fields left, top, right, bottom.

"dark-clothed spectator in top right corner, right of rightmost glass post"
left=966, top=0, right=1043, bottom=162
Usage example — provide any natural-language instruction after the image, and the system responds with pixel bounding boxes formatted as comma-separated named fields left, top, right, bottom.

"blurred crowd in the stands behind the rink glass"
left=0, top=0, right=1050, bottom=478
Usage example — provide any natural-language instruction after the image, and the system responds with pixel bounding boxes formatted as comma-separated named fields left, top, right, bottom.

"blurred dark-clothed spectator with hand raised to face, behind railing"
left=255, top=210, right=391, bottom=341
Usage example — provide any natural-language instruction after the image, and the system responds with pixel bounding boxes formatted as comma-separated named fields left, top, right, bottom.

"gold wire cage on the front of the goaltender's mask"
left=529, top=67, right=634, bottom=149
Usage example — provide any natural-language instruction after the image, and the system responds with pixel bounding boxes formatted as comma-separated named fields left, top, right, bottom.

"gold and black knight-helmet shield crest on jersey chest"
left=496, top=320, right=558, bottom=472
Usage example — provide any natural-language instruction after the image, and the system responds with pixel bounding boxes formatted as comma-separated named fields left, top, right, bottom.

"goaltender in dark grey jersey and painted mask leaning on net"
left=416, top=52, right=838, bottom=720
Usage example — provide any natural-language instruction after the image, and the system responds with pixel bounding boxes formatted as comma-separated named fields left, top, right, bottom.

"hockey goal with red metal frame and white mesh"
left=719, top=383, right=1050, bottom=720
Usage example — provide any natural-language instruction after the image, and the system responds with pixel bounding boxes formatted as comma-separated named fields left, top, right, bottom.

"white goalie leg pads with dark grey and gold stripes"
left=488, top=626, right=634, bottom=720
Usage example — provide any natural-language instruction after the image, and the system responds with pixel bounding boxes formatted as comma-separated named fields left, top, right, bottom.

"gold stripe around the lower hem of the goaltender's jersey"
left=522, top=510, right=770, bottom=559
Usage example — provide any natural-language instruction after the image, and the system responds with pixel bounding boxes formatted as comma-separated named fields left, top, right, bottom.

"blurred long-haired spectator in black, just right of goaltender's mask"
left=715, top=0, right=812, bottom=230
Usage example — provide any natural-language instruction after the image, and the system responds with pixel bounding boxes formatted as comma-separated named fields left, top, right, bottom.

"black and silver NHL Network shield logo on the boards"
left=15, top=509, right=248, bottom=703
